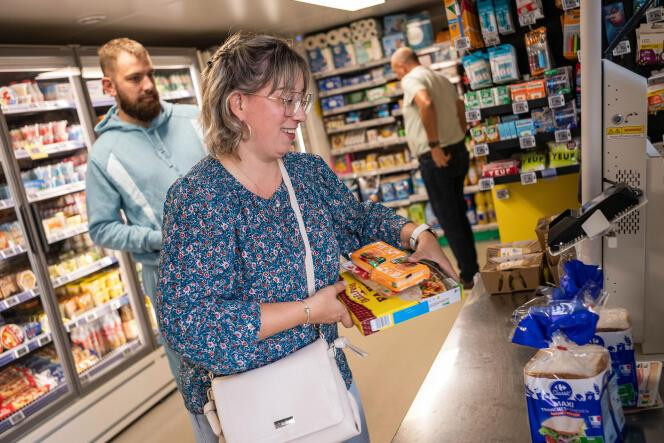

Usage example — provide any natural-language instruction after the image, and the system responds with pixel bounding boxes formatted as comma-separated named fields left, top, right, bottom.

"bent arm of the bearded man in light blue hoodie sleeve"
left=85, top=161, right=161, bottom=253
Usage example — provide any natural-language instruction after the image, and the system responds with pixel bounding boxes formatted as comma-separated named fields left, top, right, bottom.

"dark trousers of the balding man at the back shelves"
left=418, top=142, right=479, bottom=282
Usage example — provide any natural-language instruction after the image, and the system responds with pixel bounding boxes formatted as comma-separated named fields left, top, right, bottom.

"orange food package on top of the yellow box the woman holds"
left=350, top=242, right=430, bottom=292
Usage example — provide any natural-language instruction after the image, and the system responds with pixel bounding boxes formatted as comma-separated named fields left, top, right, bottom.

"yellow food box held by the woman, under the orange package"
left=339, top=267, right=462, bottom=335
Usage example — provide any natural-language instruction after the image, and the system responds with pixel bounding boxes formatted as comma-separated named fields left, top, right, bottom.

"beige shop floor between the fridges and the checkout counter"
left=113, top=242, right=493, bottom=443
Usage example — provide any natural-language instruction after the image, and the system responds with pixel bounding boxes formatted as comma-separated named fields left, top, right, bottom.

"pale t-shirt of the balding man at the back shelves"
left=401, top=66, right=464, bottom=157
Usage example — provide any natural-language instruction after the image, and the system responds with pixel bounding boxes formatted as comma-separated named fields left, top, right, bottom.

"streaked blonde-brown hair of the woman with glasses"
left=200, top=32, right=309, bottom=155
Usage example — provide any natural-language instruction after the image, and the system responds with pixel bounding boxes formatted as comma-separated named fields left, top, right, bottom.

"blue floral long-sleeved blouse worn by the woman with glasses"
left=156, top=153, right=406, bottom=414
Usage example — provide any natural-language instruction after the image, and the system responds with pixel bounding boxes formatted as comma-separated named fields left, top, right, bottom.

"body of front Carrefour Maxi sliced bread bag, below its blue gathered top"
left=524, top=345, right=625, bottom=443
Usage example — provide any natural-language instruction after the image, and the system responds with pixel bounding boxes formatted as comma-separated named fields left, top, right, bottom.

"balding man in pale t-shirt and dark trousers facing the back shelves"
left=392, top=48, right=479, bottom=288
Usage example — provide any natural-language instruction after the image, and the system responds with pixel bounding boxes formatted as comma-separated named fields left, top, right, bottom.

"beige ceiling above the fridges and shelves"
left=0, top=0, right=443, bottom=48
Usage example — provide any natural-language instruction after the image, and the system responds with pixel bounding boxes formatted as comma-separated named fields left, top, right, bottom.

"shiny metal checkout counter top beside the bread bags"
left=393, top=280, right=664, bottom=443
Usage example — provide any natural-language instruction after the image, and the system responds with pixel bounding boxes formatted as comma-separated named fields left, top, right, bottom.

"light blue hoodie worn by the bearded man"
left=86, top=101, right=206, bottom=266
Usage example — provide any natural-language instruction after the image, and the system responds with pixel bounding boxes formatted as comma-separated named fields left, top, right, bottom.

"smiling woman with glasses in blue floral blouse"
left=157, top=34, right=454, bottom=442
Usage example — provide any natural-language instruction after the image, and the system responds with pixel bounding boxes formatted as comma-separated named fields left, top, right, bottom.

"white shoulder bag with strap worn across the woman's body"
left=204, top=160, right=366, bottom=443
